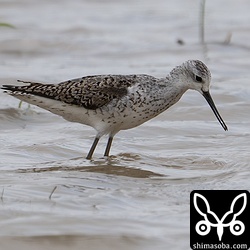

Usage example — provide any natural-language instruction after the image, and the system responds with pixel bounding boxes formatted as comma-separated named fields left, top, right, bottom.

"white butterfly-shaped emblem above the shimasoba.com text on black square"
left=193, top=193, right=247, bottom=241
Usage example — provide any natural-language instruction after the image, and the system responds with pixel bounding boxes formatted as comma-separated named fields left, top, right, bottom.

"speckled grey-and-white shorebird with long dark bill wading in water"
left=2, top=60, right=227, bottom=159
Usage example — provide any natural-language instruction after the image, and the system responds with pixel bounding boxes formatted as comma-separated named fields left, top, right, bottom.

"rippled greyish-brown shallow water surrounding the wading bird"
left=0, top=0, right=250, bottom=250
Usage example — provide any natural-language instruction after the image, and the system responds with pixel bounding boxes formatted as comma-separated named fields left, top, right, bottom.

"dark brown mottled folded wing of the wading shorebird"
left=2, top=75, right=137, bottom=109
